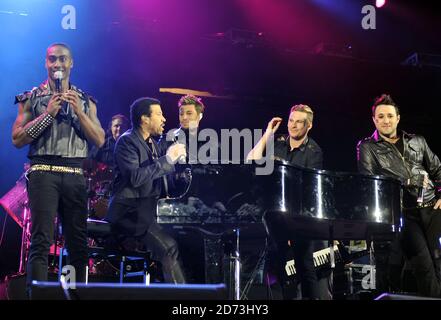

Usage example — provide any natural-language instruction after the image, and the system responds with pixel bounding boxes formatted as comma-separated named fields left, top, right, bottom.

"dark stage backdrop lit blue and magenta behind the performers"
left=0, top=0, right=441, bottom=275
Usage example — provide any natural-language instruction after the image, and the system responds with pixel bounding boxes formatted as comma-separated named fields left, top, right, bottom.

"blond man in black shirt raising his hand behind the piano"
left=247, top=104, right=323, bottom=299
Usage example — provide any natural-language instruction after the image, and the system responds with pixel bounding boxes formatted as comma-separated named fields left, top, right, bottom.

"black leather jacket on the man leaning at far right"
left=357, top=131, right=441, bottom=207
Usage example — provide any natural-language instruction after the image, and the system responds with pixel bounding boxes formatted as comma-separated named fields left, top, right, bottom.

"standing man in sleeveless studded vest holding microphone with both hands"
left=12, top=43, right=104, bottom=298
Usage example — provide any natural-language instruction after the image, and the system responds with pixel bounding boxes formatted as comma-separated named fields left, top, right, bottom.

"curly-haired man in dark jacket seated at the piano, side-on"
left=106, top=98, right=186, bottom=283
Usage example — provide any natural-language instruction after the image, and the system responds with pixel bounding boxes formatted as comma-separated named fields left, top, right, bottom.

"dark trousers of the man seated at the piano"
left=106, top=198, right=185, bottom=283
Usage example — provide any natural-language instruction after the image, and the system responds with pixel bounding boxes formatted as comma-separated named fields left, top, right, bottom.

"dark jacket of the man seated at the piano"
left=113, top=129, right=175, bottom=199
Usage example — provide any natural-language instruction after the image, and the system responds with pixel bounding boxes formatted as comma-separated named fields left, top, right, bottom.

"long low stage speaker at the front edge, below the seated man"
left=32, top=282, right=227, bottom=300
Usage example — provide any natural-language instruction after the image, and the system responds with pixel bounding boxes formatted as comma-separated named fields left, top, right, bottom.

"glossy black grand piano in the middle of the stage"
left=157, top=161, right=401, bottom=298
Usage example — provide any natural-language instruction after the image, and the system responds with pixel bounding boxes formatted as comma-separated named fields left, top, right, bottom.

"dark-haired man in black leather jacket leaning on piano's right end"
left=357, top=94, right=441, bottom=297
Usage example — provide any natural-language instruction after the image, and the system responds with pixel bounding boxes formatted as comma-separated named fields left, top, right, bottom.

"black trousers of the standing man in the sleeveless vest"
left=27, top=171, right=87, bottom=292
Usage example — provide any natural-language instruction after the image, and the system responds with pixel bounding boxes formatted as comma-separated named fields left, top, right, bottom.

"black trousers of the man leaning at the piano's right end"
left=401, top=207, right=441, bottom=297
